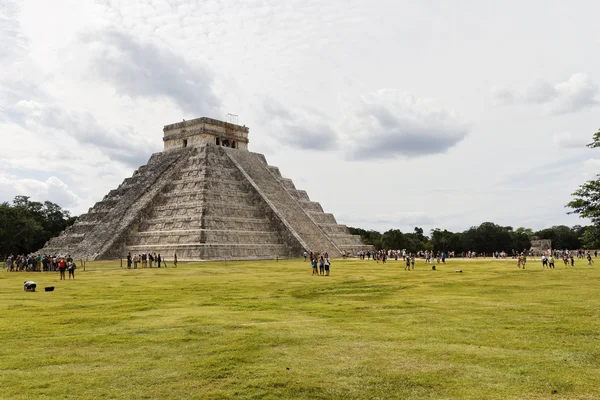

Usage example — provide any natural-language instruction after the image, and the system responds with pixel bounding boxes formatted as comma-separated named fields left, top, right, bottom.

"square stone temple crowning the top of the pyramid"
left=163, top=117, right=248, bottom=151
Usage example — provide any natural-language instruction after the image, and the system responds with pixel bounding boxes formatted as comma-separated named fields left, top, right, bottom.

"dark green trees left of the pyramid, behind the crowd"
left=0, top=196, right=75, bottom=255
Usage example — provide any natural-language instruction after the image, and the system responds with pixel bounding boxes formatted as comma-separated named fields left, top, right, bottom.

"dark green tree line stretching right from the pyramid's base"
left=349, top=222, right=600, bottom=254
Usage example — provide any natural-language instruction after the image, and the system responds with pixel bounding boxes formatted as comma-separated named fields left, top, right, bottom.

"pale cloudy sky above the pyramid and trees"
left=0, top=0, right=600, bottom=232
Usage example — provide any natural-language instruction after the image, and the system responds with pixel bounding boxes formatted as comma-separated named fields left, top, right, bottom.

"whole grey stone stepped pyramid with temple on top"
left=40, top=118, right=370, bottom=260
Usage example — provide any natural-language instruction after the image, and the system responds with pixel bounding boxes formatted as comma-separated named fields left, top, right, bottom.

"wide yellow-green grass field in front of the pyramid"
left=0, top=260, right=600, bottom=399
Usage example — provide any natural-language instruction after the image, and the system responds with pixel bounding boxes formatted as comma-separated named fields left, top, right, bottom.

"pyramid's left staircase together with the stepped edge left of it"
left=39, top=149, right=193, bottom=260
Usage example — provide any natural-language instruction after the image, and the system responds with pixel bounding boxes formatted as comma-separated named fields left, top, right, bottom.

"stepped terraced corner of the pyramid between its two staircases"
left=119, top=144, right=303, bottom=260
